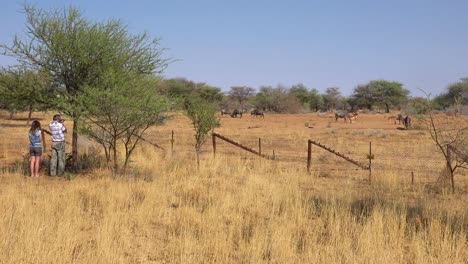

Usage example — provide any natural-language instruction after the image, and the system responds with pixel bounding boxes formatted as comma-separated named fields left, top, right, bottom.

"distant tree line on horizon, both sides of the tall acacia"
left=0, top=71, right=468, bottom=116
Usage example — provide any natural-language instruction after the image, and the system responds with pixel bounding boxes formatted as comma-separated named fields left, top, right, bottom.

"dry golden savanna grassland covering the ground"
left=0, top=112, right=468, bottom=264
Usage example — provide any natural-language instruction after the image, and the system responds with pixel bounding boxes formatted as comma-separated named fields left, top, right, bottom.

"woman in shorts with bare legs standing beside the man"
left=29, top=120, right=45, bottom=178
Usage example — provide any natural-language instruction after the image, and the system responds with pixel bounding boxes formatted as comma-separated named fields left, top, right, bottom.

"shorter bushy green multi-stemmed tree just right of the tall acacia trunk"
left=79, top=72, right=169, bottom=172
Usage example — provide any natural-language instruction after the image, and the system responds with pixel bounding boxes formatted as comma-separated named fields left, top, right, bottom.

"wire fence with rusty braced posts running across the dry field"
left=0, top=127, right=467, bottom=186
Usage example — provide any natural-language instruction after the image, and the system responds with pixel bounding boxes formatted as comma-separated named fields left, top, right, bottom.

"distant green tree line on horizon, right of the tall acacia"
left=150, top=78, right=468, bottom=113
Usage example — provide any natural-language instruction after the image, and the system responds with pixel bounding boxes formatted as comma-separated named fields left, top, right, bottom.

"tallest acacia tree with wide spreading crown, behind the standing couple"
left=0, top=4, right=168, bottom=170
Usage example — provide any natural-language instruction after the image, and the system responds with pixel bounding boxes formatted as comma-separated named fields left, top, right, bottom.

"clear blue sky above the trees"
left=0, top=0, right=468, bottom=96
